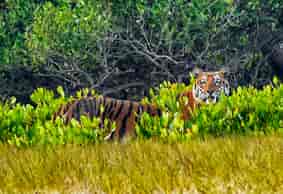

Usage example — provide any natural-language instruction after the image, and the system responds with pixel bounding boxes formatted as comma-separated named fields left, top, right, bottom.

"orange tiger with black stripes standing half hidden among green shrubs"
left=53, top=69, right=230, bottom=140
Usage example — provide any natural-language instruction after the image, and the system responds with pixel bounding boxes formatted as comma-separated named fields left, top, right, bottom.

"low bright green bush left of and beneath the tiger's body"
left=0, top=87, right=108, bottom=146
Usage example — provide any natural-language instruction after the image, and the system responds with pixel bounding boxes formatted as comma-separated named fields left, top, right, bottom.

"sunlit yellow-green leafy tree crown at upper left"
left=26, top=1, right=110, bottom=65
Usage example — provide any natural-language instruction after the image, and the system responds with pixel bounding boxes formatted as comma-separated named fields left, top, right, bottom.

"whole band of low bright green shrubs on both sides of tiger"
left=0, top=79, right=283, bottom=146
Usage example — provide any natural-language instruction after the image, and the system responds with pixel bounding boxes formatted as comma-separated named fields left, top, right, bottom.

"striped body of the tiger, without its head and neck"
left=53, top=96, right=161, bottom=139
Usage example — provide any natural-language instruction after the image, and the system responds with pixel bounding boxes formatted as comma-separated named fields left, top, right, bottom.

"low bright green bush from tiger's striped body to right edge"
left=136, top=79, right=283, bottom=141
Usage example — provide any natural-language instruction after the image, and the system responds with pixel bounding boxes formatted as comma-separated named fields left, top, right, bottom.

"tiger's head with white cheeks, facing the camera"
left=192, top=69, right=230, bottom=104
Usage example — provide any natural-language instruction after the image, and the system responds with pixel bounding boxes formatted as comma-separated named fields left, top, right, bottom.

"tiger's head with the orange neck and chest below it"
left=179, top=68, right=231, bottom=120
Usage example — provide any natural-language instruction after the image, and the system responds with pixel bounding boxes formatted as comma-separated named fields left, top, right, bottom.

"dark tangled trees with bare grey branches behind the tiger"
left=0, top=0, right=283, bottom=102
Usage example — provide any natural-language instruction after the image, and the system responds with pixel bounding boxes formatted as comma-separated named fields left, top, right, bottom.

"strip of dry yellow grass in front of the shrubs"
left=0, top=136, right=283, bottom=194
